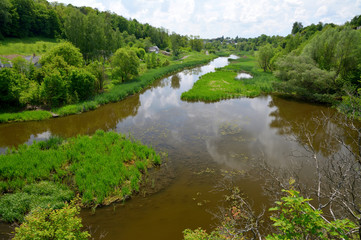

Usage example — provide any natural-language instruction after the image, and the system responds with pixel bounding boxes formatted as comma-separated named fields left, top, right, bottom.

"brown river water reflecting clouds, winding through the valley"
left=0, top=58, right=344, bottom=240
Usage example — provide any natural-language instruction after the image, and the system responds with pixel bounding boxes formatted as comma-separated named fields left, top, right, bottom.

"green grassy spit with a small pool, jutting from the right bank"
left=181, top=54, right=277, bottom=102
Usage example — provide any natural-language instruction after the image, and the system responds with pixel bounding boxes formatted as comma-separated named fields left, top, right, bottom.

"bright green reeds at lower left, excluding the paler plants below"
left=0, top=131, right=160, bottom=205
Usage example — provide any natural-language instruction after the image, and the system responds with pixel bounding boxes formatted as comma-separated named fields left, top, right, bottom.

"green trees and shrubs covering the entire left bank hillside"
left=0, top=0, right=208, bottom=122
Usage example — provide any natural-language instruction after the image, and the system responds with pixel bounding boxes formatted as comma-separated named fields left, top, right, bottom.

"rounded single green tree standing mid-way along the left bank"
left=111, top=48, right=139, bottom=82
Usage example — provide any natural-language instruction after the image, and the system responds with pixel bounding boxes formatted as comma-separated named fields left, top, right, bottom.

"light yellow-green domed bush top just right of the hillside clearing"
left=40, top=42, right=83, bottom=67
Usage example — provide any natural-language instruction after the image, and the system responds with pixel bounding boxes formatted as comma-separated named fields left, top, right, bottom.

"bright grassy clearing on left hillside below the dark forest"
left=0, top=37, right=58, bottom=55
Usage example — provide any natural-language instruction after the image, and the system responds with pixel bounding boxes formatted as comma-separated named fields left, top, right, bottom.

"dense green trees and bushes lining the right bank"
left=201, top=16, right=361, bottom=116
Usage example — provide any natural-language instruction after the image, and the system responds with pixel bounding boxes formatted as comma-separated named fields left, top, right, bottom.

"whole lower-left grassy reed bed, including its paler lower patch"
left=0, top=130, right=161, bottom=222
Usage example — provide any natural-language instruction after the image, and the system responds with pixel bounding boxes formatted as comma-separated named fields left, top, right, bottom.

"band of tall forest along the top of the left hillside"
left=0, top=0, right=203, bottom=60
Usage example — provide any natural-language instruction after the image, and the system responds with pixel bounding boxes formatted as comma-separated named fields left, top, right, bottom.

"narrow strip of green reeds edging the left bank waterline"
left=0, top=52, right=217, bottom=123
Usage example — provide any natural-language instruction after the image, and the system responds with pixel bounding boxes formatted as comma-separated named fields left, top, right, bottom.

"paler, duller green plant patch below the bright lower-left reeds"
left=0, top=181, right=74, bottom=222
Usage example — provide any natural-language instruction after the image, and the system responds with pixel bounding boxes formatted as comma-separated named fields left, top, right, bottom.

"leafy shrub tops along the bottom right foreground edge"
left=183, top=189, right=356, bottom=240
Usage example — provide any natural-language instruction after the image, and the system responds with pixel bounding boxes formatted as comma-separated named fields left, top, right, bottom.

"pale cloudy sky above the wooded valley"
left=51, top=0, right=361, bottom=38
